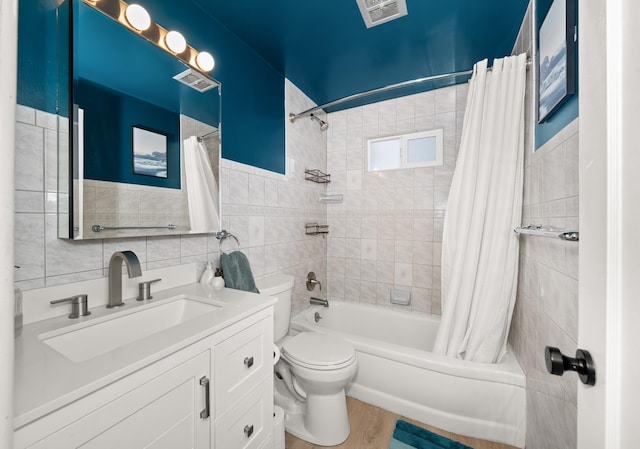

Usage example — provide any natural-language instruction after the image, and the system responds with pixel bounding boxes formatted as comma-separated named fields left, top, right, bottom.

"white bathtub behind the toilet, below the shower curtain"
left=291, top=301, right=526, bottom=448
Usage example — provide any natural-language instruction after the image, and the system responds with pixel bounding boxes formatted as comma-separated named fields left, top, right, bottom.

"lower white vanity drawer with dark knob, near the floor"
left=215, top=377, right=273, bottom=449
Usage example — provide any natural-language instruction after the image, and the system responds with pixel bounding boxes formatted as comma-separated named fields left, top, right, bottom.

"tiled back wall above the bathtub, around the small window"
left=327, top=84, right=468, bottom=314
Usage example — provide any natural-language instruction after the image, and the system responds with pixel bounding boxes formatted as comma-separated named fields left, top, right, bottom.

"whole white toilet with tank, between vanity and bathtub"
left=256, top=274, right=358, bottom=446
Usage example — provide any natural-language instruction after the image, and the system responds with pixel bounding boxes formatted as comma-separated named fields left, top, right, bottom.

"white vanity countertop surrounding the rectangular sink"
left=14, top=284, right=275, bottom=429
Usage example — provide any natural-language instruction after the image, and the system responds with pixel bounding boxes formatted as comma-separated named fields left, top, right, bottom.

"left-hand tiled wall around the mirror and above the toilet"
left=14, top=77, right=326, bottom=311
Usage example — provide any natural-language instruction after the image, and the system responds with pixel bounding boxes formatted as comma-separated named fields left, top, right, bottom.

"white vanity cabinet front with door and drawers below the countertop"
left=14, top=308, right=273, bottom=449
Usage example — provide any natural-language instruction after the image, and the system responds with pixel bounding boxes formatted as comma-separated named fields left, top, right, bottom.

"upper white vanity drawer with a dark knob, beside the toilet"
left=213, top=320, right=273, bottom=414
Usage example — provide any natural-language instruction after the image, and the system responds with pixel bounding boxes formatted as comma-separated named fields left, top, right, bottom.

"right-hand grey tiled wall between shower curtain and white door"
left=509, top=1, right=579, bottom=449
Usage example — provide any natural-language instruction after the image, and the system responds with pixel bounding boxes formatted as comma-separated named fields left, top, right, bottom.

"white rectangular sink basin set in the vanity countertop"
left=39, top=297, right=220, bottom=362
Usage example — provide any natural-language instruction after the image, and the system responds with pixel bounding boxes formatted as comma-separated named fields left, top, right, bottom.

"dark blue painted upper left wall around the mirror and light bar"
left=17, top=0, right=285, bottom=173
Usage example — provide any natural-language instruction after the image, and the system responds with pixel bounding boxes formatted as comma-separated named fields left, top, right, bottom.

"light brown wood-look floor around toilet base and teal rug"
left=285, top=397, right=516, bottom=449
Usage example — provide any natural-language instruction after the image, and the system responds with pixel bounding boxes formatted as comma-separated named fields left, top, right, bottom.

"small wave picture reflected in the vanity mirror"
left=133, top=126, right=167, bottom=178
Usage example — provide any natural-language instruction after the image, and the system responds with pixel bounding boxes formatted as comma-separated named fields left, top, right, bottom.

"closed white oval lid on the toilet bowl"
left=281, top=332, right=356, bottom=367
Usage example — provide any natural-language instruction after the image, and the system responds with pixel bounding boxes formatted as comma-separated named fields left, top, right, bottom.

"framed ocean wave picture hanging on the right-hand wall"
left=538, top=0, right=577, bottom=123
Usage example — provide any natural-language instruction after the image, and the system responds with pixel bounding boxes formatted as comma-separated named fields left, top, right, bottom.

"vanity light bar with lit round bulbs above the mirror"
left=83, top=0, right=218, bottom=75
